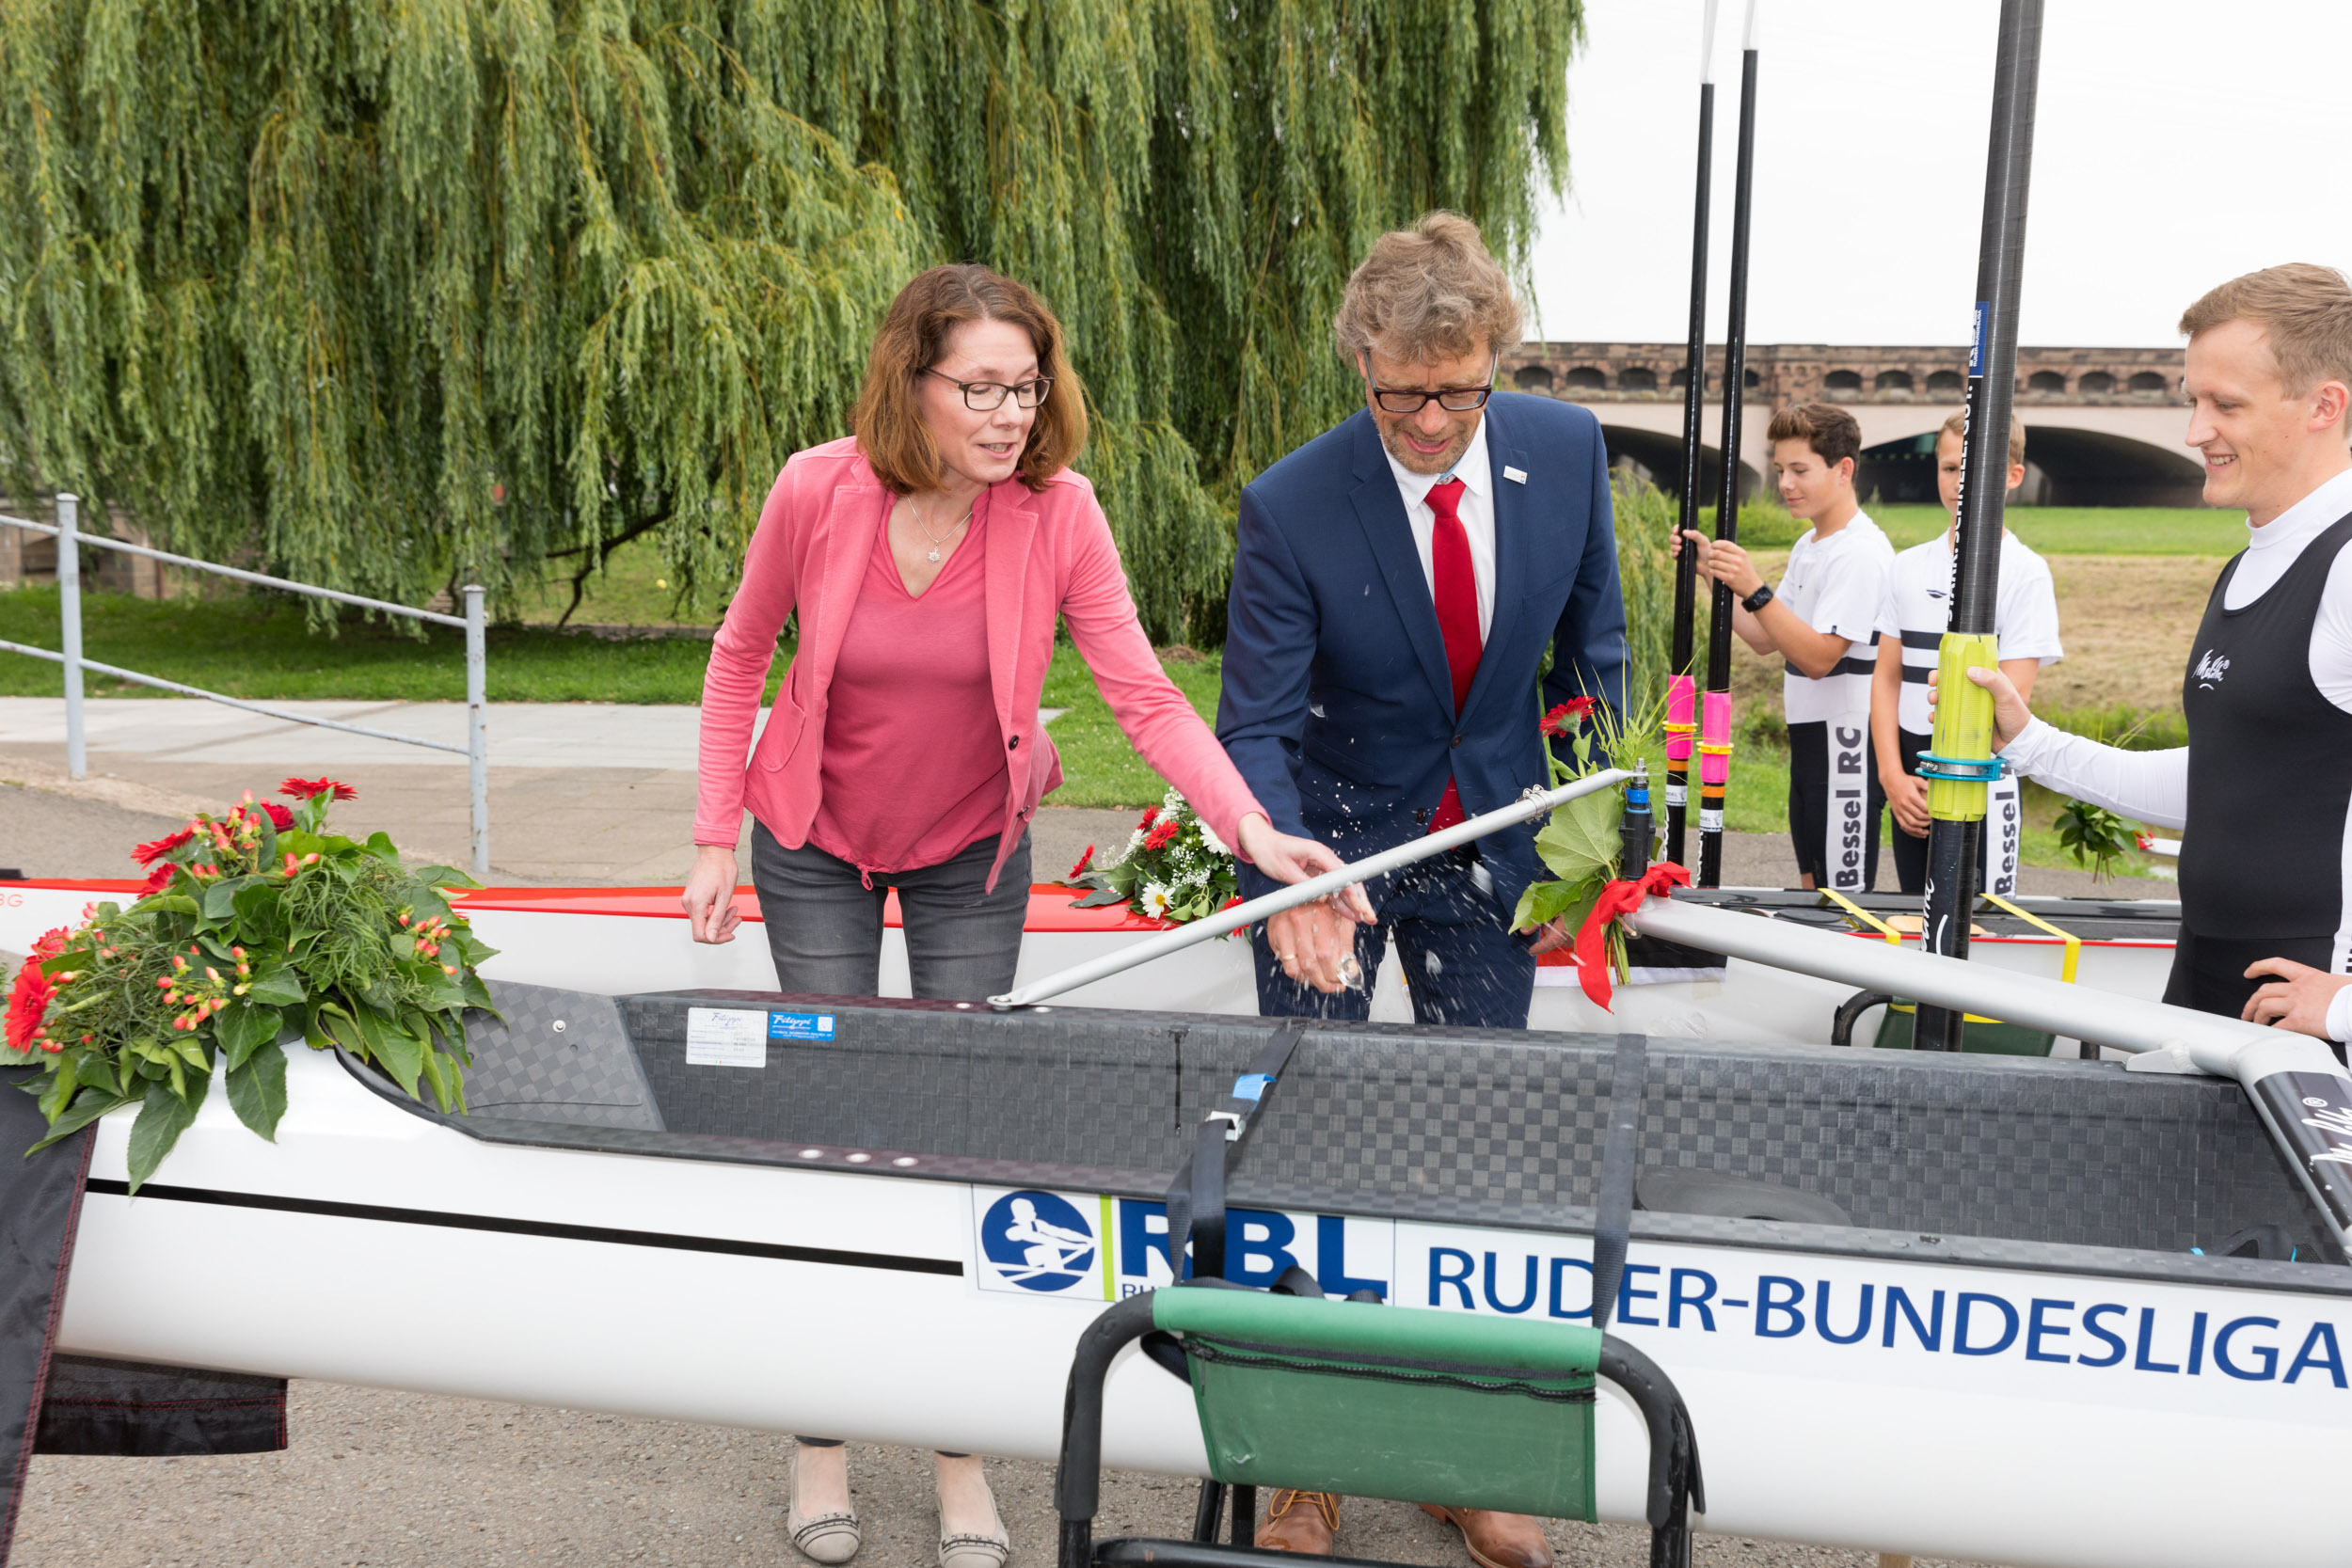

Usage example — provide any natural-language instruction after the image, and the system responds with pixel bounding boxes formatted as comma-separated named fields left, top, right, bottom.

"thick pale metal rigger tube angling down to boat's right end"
left=1626, top=898, right=2352, bottom=1256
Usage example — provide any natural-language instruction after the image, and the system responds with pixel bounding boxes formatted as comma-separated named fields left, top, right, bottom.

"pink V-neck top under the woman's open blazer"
left=809, top=496, right=1007, bottom=886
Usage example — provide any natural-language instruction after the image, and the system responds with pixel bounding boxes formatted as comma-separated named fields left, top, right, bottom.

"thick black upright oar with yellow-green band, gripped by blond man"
left=1913, top=0, right=2042, bottom=1051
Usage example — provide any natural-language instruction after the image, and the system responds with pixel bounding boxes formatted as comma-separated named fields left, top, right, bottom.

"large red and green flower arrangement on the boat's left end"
left=0, top=778, right=492, bottom=1192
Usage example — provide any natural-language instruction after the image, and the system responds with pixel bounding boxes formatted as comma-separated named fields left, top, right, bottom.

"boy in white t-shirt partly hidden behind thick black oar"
left=1870, top=414, right=2063, bottom=895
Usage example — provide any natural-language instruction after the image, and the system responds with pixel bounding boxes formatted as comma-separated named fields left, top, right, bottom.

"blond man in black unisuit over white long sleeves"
left=1969, top=263, right=2352, bottom=1041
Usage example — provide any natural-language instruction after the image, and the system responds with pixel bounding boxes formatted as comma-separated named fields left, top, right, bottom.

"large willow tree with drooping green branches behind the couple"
left=0, top=0, right=1581, bottom=637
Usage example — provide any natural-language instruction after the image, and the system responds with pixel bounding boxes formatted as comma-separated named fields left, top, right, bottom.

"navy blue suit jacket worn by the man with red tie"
left=1216, top=392, right=1626, bottom=917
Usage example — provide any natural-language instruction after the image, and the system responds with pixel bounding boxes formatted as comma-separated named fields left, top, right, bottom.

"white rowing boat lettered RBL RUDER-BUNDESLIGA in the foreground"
left=0, top=869, right=2352, bottom=1568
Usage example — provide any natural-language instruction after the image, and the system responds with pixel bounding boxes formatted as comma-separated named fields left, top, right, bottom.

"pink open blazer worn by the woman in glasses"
left=694, top=437, right=1263, bottom=886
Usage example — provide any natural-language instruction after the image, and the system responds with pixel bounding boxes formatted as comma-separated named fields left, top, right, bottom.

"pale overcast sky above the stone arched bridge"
left=1534, top=0, right=2352, bottom=348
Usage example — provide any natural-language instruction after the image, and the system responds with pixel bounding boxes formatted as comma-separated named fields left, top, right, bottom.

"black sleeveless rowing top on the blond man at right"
left=2181, top=517, right=2352, bottom=938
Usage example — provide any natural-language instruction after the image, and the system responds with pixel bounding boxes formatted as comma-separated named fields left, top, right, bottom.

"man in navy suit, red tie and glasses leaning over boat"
left=1216, top=212, right=1626, bottom=1030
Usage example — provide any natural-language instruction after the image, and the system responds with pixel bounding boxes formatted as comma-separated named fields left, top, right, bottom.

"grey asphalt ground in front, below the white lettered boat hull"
left=14, top=1383, right=1985, bottom=1568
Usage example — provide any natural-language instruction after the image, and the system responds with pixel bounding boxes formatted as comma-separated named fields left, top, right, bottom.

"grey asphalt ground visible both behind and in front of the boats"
left=0, top=743, right=2117, bottom=1568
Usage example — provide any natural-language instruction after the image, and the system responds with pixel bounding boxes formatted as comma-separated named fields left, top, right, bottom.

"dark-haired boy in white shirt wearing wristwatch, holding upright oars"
left=1687, top=402, right=1896, bottom=894
